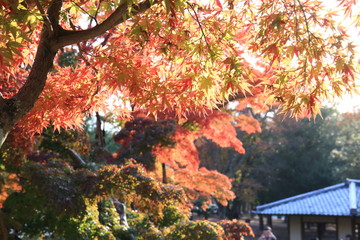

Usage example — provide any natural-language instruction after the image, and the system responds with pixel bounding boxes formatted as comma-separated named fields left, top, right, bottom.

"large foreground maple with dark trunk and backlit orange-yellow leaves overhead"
left=0, top=0, right=357, bottom=148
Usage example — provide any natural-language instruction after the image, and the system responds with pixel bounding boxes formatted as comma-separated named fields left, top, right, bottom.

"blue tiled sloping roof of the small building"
left=253, top=179, right=360, bottom=216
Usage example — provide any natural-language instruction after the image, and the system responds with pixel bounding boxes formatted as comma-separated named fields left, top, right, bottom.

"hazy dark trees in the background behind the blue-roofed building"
left=197, top=106, right=346, bottom=217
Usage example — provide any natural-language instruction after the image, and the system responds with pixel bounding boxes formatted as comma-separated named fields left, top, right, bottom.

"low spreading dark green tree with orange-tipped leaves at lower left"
left=3, top=159, right=186, bottom=239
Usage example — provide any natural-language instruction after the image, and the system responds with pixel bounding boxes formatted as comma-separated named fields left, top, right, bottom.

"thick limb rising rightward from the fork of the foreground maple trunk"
left=52, top=0, right=158, bottom=49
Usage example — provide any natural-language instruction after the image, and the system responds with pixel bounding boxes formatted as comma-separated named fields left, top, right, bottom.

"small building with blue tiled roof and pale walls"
left=253, top=179, right=360, bottom=240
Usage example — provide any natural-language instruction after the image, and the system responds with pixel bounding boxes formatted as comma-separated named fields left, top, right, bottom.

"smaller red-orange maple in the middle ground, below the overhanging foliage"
left=111, top=116, right=236, bottom=210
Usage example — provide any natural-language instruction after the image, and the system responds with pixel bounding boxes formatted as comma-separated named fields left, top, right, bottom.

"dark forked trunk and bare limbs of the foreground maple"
left=0, top=0, right=153, bottom=133
